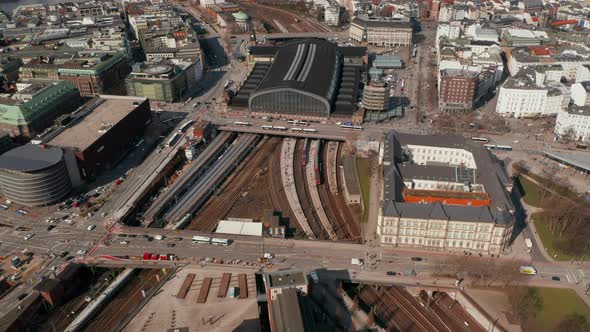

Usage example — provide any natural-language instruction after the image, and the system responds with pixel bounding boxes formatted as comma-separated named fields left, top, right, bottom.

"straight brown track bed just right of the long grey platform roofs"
left=188, top=137, right=281, bottom=232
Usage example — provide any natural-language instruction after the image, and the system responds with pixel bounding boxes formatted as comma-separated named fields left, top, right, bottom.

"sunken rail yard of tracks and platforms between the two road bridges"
left=143, top=128, right=361, bottom=241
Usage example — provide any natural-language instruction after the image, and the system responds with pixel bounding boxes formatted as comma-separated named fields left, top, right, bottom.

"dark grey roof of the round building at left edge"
left=0, top=144, right=63, bottom=172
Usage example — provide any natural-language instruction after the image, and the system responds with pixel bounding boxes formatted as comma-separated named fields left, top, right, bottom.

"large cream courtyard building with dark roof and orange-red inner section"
left=377, top=132, right=514, bottom=254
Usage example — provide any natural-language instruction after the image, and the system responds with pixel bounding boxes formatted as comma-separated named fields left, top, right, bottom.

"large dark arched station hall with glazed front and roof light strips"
left=229, top=39, right=364, bottom=119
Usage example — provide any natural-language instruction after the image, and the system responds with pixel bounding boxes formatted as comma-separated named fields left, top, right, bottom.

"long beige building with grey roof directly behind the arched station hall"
left=349, top=16, right=413, bottom=46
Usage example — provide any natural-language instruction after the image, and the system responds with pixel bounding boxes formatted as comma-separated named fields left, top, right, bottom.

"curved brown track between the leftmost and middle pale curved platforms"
left=293, top=139, right=329, bottom=240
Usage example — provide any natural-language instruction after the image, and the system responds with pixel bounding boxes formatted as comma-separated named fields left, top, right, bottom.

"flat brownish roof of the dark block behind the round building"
left=47, top=95, right=147, bottom=151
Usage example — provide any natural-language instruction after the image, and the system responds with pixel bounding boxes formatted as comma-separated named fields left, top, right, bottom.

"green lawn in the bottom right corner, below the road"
left=532, top=288, right=590, bottom=331
